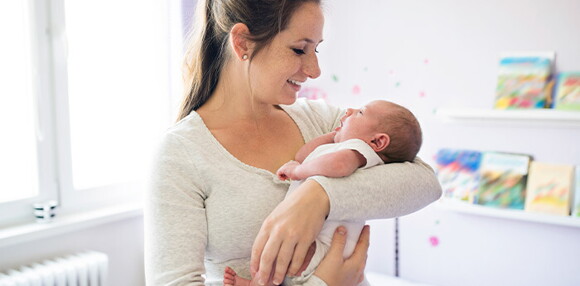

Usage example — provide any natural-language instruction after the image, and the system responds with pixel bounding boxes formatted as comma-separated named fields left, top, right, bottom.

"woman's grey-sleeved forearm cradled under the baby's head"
left=310, top=158, right=441, bottom=220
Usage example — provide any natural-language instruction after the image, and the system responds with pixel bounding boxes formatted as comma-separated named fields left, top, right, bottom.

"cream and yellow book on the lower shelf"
left=525, top=161, right=574, bottom=216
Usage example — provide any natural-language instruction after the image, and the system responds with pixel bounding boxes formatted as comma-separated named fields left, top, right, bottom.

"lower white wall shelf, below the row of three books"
left=436, top=199, right=580, bottom=228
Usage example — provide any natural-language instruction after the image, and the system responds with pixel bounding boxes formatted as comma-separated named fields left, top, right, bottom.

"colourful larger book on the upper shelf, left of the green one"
left=494, top=52, right=555, bottom=109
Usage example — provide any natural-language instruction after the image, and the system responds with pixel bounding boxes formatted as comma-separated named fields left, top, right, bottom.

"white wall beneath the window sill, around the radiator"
left=0, top=217, right=145, bottom=286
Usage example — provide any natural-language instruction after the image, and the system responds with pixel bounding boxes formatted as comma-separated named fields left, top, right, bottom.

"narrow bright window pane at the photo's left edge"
left=0, top=1, right=38, bottom=203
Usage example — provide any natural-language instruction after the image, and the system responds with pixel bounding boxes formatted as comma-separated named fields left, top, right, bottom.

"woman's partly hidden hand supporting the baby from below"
left=314, top=225, right=370, bottom=286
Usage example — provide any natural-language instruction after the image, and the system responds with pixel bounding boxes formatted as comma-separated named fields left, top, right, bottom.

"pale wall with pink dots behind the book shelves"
left=310, top=0, right=580, bottom=286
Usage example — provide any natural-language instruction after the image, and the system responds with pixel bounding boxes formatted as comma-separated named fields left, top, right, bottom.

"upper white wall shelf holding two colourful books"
left=435, top=108, right=580, bottom=127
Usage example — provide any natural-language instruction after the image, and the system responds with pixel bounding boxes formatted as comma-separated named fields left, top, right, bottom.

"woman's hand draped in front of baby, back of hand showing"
left=250, top=180, right=330, bottom=285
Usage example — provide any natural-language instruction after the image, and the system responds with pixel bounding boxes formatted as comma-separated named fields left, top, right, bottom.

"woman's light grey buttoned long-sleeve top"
left=145, top=99, right=441, bottom=285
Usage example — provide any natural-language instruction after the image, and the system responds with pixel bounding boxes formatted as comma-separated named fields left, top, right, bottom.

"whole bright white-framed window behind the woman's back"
left=0, top=0, right=180, bottom=228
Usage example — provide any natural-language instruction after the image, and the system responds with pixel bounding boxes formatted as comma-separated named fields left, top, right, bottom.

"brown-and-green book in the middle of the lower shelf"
left=474, top=152, right=532, bottom=209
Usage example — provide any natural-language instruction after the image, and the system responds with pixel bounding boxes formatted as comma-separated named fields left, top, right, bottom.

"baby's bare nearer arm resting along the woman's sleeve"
left=277, top=149, right=366, bottom=180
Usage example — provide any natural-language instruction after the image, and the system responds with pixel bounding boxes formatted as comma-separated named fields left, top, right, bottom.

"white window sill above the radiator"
left=0, top=203, right=143, bottom=248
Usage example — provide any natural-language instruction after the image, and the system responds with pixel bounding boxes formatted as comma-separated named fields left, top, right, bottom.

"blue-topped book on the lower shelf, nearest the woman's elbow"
left=435, top=149, right=482, bottom=203
